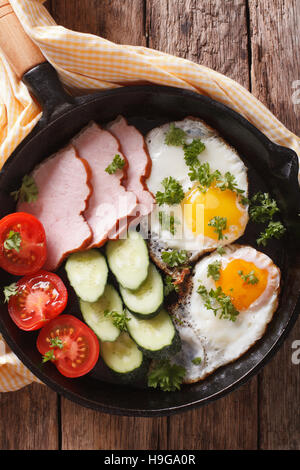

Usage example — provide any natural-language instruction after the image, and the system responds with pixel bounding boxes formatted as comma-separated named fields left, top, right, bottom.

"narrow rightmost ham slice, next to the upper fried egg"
left=108, top=116, right=154, bottom=216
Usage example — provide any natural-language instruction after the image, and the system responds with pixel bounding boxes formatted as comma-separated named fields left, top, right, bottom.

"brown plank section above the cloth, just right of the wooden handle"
left=51, top=0, right=146, bottom=46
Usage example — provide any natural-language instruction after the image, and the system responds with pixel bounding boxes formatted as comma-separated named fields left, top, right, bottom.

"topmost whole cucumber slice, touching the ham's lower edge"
left=106, top=231, right=149, bottom=290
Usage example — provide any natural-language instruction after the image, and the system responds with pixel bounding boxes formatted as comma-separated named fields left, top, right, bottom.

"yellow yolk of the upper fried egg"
left=182, top=185, right=245, bottom=240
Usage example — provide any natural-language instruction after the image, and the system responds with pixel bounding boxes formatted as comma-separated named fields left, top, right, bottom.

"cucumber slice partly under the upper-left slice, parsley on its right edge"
left=80, top=284, right=123, bottom=341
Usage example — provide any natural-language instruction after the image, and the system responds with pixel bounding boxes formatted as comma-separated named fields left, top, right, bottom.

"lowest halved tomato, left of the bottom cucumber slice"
left=36, top=315, right=99, bottom=377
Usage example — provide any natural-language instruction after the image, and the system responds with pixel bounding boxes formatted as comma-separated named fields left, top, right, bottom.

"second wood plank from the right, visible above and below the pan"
left=147, top=0, right=257, bottom=449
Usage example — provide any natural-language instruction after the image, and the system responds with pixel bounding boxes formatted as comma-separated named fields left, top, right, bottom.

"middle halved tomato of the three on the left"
left=8, top=271, right=68, bottom=331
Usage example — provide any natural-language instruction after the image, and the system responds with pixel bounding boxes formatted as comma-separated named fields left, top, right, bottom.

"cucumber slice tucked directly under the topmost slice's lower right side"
left=120, top=263, right=164, bottom=318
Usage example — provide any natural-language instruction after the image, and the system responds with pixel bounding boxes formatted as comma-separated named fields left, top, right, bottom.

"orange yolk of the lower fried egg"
left=216, top=259, right=268, bottom=311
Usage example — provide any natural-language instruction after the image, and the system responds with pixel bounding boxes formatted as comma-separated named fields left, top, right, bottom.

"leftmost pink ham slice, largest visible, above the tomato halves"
left=18, top=145, right=92, bottom=271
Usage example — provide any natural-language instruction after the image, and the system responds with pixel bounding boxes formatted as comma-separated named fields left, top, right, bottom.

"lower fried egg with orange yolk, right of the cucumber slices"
left=172, top=245, right=280, bottom=383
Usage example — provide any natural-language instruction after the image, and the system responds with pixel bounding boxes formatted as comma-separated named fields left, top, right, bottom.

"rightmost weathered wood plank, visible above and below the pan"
left=249, top=0, right=300, bottom=449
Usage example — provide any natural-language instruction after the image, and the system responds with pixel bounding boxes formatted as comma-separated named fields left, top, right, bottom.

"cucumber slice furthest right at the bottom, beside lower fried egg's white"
left=126, top=309, right=181, bottom=360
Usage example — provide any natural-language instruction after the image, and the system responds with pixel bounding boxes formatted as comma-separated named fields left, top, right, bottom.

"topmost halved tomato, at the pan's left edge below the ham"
left=0, top=212, right=47, bottom=276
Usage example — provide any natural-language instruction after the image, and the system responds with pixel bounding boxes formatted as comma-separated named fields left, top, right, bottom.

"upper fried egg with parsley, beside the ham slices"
left=146, top=118, right=248, bottom=259
